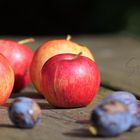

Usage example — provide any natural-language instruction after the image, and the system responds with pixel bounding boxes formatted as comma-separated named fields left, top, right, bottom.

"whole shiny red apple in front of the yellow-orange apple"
left=41, top=54, right=100, bottom=108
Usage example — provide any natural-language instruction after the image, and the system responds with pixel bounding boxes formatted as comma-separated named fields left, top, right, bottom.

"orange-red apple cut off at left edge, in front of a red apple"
left=0, top=54, right=15, bottom=105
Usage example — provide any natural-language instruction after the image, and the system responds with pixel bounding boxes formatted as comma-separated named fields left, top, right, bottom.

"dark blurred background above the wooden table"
left=0, top=0, right=140, bottom=35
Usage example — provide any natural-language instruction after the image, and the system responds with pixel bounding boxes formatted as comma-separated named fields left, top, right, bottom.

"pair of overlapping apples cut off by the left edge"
left=0, top=38, right=34, bottom=105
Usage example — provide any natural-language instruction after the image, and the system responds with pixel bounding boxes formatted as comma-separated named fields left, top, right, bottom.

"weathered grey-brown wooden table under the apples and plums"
left=0, top=34, right=140, bottom=140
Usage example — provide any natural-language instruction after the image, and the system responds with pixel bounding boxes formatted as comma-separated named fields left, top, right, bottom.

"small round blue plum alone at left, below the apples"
left=8, top=97, right=41, bottom=128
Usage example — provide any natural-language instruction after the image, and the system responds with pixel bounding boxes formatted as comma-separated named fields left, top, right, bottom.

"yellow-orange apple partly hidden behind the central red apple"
left=30, top=39, right=94, bottom=93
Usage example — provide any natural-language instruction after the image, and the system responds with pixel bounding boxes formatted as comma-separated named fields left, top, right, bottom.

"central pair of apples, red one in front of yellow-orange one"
left=30, top=37, right=100, bottom=108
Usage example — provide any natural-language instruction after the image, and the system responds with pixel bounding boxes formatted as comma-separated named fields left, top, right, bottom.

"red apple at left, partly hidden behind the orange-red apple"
left=0, top=40, right=33, bottom=92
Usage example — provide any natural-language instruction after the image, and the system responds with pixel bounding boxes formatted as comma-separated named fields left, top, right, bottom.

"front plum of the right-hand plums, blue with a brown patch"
left=90, top=100, right=133, bottom=136
